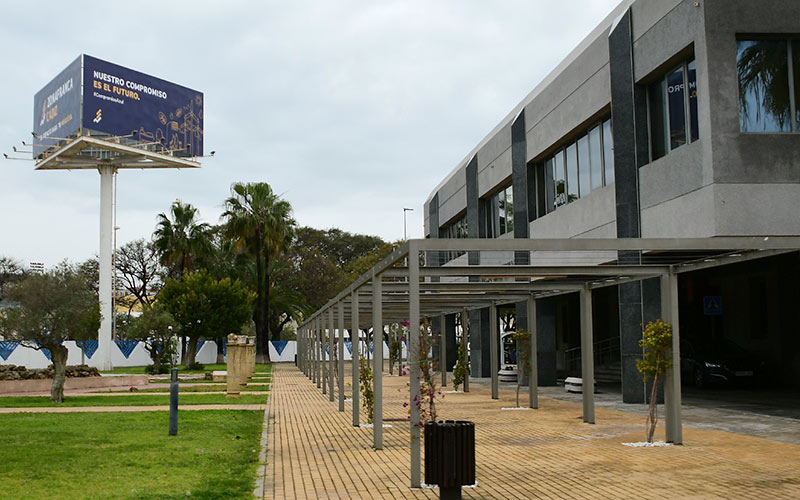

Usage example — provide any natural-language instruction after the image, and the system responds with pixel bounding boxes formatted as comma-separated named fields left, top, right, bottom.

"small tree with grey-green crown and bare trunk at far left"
left=0, top=262, right=100, bottom=403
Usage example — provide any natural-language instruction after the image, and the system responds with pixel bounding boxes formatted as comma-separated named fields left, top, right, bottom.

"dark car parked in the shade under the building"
left=681, top=340, right=763, bottom=387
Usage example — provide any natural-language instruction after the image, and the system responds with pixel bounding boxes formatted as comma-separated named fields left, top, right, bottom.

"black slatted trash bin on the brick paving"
left=424, top=420, right=475, bottom=500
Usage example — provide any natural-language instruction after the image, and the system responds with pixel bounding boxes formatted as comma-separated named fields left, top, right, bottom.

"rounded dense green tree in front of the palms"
left=157, top=269, right=253, bottom=366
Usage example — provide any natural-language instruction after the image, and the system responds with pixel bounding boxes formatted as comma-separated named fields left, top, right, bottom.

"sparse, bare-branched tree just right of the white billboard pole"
left=116, top=239, right=162, bottom=313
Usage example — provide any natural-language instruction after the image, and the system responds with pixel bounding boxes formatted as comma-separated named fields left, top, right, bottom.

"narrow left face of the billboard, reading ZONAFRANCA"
left=33, top=57, right=81, bottom=156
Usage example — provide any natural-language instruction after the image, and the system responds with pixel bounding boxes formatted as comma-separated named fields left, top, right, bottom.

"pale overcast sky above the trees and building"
left=0, top=0, right=619, bottom=266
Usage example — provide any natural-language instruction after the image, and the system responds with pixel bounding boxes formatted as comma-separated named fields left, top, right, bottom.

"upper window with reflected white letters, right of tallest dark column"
left=647, top=60, right=700, bottom=160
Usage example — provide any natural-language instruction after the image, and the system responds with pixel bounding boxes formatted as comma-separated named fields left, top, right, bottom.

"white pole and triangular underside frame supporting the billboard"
left=36, top=135, right=200, bottom=370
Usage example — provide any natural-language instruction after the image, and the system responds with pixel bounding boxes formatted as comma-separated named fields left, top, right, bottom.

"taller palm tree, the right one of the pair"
left=222, top=182, right=295, bottom=363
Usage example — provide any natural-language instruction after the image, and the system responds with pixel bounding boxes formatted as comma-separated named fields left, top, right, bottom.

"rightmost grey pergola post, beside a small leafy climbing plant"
left=661, top=273, right=683, bottom=444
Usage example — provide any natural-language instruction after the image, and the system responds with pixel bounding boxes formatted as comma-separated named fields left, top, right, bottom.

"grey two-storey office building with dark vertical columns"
left=425, top=0, right=800, bottom=402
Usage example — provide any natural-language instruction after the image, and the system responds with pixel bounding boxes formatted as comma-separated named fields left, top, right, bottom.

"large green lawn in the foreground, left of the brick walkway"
left=0, top=410, right=264, bottom=500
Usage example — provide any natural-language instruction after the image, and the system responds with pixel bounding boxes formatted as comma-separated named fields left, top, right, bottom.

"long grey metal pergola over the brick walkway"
left=297, top=236, right=800, bottom=487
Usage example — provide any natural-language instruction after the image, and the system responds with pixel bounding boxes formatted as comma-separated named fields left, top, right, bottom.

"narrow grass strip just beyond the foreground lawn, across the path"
left=0, top=392, right=267, bottom=408
